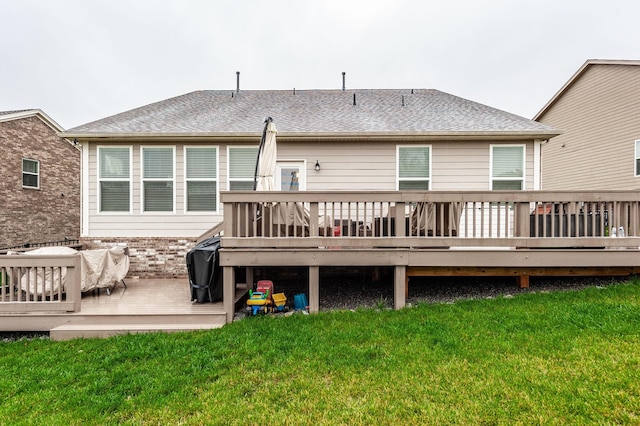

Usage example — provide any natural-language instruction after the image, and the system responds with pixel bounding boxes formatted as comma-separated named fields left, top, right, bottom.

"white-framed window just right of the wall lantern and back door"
left=396, top=146, right=431, bottom=191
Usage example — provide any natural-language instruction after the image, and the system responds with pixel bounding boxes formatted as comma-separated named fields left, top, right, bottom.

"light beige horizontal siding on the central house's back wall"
left=85, top=140, right=533, bottom=238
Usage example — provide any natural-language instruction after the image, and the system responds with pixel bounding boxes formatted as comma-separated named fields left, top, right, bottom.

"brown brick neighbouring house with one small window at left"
left=0, top=109, right=80, bottom=249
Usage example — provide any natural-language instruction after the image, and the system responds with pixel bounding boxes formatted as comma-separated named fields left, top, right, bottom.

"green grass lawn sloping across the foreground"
left=0, top=279, right=640, bottom=425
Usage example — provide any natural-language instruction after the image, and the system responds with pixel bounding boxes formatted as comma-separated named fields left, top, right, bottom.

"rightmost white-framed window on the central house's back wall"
left=491, top=145, right=524, bottom=190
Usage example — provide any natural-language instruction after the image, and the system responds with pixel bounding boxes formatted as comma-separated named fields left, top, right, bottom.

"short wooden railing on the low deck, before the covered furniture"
left=0, top=255, right=81, bottom=313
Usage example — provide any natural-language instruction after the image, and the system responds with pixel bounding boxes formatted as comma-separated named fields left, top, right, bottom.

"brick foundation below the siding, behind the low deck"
left=81, top=238, right=195, bottom=278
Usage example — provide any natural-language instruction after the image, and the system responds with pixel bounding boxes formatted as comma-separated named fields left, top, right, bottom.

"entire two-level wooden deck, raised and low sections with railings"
left=0, top=191, right=640, bottom=339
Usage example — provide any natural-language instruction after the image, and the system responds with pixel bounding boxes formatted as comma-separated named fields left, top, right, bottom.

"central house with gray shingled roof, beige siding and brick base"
left=62, top=89, right=558, bottom=276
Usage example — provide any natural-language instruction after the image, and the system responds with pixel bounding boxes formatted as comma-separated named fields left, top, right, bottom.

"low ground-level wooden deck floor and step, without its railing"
left=0, top=278, right=244, bottom=340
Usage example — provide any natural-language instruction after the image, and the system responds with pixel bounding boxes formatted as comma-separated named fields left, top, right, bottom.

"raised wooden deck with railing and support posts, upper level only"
left=220, top=191, right=640, bottom=312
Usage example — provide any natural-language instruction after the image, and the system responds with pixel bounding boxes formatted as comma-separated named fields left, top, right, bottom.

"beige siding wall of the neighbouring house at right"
left=538, top=64, right=640, bottom=190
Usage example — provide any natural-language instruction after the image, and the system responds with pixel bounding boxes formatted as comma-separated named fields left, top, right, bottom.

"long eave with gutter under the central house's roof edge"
left=59, top=130, right=561, bottom=142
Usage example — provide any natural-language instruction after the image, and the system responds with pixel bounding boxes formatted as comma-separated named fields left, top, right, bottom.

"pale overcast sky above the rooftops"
left=0, top=0, right=640, bottom=130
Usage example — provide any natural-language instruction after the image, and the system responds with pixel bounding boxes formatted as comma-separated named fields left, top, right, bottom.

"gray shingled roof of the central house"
left=65, top=89, right=558, bottom=137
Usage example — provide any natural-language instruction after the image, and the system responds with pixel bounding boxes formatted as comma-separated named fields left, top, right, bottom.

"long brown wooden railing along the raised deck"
left=221, top=191, right=640, bottom=248
